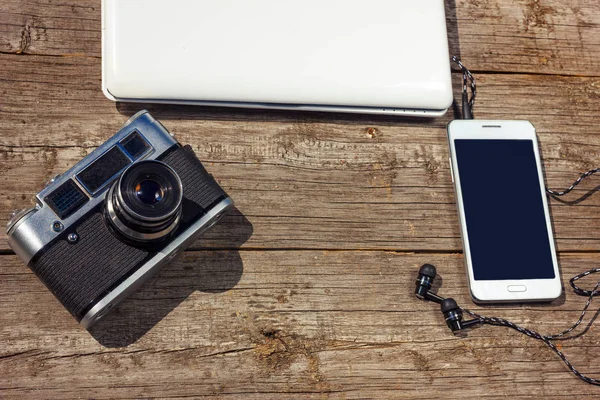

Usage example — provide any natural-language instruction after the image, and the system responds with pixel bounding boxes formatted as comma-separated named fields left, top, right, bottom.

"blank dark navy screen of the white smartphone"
left=454, top=139, right=555, bottom=280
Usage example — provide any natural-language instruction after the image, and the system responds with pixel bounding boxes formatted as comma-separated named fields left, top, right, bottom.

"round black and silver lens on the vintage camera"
left=106, top=161, right=183, bottom=242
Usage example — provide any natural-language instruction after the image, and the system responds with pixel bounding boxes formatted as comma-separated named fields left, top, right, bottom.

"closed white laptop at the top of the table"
left=102, top=0, right=452, bottom=117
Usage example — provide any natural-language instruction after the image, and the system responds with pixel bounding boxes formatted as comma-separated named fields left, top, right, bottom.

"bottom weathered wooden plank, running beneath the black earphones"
left=0, top=251, right=600, bottom=399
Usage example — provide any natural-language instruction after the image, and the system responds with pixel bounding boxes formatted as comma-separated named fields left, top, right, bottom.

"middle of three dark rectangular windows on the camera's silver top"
left=77, top=146, right=131, bottom=195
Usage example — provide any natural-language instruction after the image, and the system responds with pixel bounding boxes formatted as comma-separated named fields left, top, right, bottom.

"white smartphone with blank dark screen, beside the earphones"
left=448, top=120, right=562, bottom=303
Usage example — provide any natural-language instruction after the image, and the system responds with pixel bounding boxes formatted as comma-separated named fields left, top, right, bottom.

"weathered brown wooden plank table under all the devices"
left=0, top=0, right=600, bottom=399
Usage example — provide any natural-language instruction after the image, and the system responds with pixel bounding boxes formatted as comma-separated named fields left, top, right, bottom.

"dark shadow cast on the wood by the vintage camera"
left=89, top=207, right=253, bottom=348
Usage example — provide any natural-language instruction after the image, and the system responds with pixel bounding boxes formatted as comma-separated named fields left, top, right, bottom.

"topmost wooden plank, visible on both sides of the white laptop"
left=0, top=0, right=600, bottom=76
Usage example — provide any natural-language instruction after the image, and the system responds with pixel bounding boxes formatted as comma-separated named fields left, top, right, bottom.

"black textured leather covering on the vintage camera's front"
left=29, top=145, right=227, bottom=321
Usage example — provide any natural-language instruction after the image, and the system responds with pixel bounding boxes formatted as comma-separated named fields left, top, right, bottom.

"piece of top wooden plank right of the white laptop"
left=446, top=0, right=600, bottom=76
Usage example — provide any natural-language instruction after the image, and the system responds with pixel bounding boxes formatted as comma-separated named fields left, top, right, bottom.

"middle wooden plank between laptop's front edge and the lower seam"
left=0, top=55, right=600, bottom=251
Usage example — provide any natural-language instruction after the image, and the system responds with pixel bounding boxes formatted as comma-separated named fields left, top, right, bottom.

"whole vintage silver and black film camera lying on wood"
left=7, top=111, right=233, bottom=328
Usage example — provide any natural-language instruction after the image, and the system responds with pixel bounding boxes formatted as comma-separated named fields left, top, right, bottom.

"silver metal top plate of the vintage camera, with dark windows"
left=7, top=110, right=177, bottom=263
